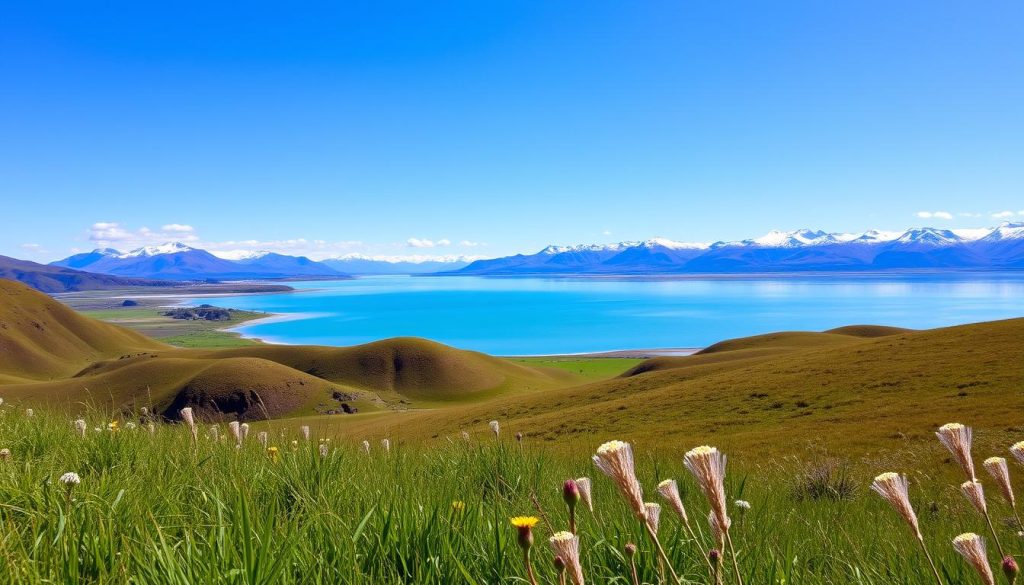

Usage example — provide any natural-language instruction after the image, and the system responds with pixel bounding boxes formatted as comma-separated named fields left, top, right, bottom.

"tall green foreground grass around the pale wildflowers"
left=0, top=406, right=1022, bottom=585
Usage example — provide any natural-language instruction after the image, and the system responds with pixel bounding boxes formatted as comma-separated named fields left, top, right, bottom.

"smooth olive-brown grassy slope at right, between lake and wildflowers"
left=311, top=320, right=1024, bottom=454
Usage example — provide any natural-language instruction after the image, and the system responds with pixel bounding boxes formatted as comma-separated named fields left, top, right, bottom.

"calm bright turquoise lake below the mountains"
left=203, top=275, right=1024, bottom=356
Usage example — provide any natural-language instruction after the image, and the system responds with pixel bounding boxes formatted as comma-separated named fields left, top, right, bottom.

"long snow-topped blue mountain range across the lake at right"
left=437, top=222, right=1024, bottom=276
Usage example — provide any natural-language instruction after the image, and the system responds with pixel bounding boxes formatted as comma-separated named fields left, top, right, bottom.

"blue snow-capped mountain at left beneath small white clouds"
left=52, top=242, right=346, bottom=281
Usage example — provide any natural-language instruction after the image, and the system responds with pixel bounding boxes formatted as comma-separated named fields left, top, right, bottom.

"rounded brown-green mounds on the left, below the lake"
left=0, top=281, right=573, bottom=419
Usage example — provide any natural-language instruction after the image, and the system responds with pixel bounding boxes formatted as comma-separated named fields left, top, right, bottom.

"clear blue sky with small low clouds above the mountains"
left=0, top=0, right=1024, bottom=261
